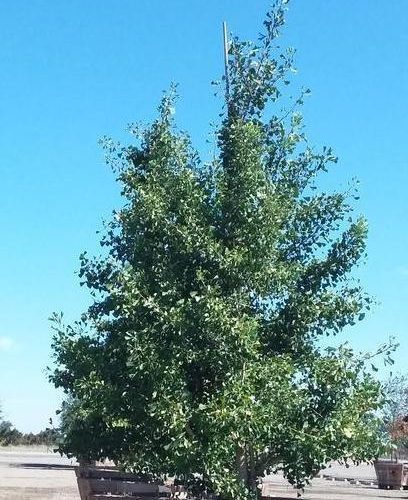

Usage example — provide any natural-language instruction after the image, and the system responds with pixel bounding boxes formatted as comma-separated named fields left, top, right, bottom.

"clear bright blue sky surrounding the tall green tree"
left=0, top=0, right=408, bottom=431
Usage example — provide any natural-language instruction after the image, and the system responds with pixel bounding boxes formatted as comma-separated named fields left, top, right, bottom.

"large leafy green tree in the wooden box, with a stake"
left=51, top=1, right=388, bottom=500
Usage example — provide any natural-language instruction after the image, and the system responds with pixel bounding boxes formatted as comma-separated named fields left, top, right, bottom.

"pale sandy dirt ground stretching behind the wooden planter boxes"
left=0, top=448, right=408, bottom=500
